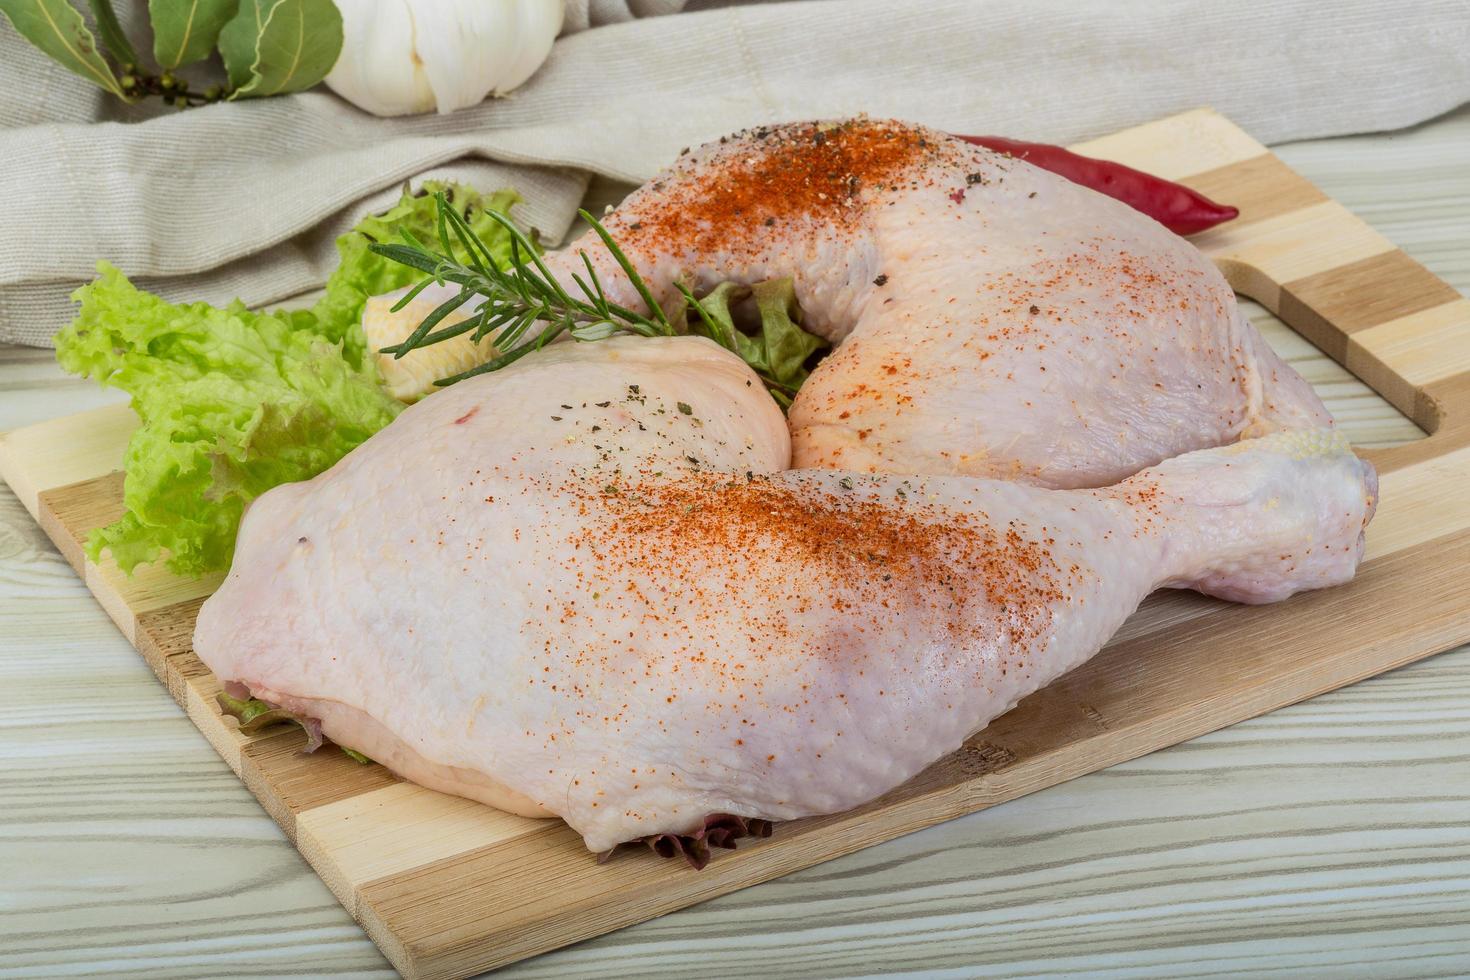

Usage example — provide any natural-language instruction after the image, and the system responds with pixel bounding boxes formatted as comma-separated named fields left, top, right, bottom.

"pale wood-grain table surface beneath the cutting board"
left=0, top=110, right=1470, bottom=979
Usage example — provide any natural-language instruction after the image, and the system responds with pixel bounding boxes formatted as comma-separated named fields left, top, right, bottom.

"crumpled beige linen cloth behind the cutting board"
left=0, top=0, right=1470, bottom=344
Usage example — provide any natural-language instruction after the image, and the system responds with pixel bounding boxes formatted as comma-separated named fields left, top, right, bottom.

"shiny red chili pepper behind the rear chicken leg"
left=960, top=137, right=1241, bottom=235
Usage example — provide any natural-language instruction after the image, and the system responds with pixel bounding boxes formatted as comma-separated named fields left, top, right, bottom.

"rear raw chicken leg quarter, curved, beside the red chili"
left=548, top=119, right=1332, bottom=486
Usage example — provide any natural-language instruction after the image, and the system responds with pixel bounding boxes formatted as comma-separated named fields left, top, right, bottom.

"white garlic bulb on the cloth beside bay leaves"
left=326, top=0, right=563, bottom=116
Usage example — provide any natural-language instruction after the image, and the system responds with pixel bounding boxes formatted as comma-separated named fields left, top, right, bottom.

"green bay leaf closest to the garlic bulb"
left=219, top=0, right=343, bottom=98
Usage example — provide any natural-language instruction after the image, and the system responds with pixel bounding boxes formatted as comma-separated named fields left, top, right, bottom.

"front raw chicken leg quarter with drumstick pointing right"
left=196, top=338, right=1374, bottom=851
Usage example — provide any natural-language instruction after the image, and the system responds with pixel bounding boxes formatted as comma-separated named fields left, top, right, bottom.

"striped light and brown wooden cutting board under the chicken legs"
left=0, top=110, right=1470, bottom=977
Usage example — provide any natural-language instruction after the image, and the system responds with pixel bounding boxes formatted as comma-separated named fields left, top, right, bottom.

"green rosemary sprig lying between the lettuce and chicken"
left=369, top=192, right=795, bottom=399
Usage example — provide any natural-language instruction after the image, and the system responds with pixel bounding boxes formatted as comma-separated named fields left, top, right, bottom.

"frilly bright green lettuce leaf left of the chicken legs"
left=56, top=184, right=529, bottom=576
